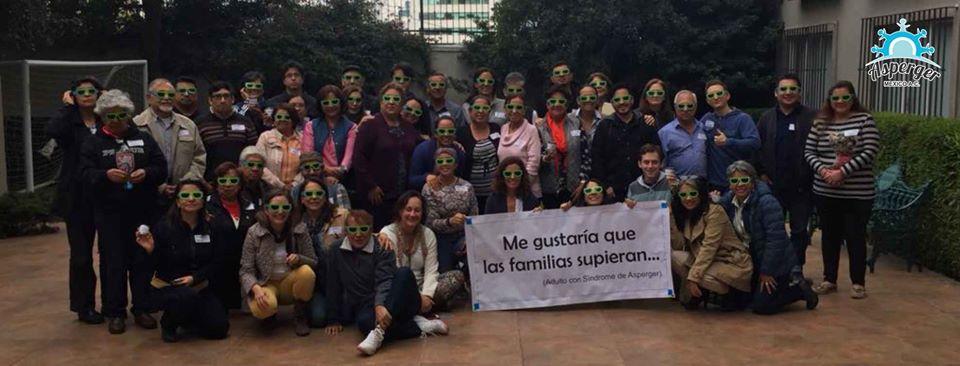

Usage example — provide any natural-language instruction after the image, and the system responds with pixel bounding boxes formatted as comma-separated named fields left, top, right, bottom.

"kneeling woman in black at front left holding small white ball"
left=136, top=180, right=230, bottom=342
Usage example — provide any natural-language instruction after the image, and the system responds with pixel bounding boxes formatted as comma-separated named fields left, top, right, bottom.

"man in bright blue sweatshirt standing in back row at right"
left=701, top=80, right=760, bottom=193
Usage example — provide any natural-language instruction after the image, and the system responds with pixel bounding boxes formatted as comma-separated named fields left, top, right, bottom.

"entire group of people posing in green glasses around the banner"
left=46, top=62, right=879, bottom=354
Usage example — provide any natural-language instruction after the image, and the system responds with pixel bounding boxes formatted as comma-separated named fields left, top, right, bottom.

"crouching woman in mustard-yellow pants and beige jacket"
left=240, top=192, right=317, bottom=337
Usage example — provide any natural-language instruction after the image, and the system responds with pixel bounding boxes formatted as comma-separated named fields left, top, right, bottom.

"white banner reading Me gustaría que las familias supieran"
left=466, top=202, right=673, bottom=311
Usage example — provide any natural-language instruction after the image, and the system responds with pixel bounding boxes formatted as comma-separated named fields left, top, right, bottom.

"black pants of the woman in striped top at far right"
left=814, top=195, right=873, bottom=285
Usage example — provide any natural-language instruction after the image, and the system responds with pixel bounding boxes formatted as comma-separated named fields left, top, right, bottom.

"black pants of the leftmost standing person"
left=66, top=204, right=97, bottom=312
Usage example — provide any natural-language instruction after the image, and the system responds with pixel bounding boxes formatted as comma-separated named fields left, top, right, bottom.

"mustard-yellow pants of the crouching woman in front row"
left=247, top=265, right=317, bottom=319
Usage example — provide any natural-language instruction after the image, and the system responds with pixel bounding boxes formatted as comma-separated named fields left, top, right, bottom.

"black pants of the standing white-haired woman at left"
left=94, top=212, right=153, bottom=317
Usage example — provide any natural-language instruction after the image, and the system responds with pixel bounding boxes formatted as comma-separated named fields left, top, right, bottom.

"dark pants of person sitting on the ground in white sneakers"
left=357, top=267, right=422, bottom=340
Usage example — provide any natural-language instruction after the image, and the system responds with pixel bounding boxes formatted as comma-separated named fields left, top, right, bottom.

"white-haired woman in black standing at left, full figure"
left=80, top=90, right=167, bottom=334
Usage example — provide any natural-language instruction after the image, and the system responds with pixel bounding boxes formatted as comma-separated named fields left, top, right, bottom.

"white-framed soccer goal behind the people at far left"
left=0, top=60, right=147, bottom=191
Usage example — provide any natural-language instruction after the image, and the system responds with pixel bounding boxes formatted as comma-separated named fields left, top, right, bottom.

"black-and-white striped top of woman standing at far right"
left=804, top=113, right=880, bottom=200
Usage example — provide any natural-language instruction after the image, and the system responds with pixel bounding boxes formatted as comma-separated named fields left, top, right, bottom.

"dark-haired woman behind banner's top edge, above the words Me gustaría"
left=484, top=156, right=541, bottom=214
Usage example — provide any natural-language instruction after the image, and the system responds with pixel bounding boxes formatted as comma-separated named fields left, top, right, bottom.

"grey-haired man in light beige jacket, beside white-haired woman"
left=133, top=79, right=207, bottom=204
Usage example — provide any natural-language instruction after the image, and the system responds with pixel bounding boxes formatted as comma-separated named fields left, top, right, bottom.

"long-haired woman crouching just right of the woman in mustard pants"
left=294, top=178, right=350, bottom=328
